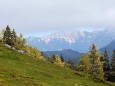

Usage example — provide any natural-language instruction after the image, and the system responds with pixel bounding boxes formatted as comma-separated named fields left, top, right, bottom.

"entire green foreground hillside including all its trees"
left=0, top=26, right=115, bottom=86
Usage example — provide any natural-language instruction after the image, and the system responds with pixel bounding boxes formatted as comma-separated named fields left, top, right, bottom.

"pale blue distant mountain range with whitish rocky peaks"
left=26, top=29, right=115, bottom=53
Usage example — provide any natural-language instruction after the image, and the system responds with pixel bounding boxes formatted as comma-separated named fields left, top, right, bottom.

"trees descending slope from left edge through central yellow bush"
left=0, top=25, right=65, bottom=67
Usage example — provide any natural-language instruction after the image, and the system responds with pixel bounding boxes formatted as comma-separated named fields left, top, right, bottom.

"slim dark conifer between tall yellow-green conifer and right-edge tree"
left=103, top=49, right=110, bottom=80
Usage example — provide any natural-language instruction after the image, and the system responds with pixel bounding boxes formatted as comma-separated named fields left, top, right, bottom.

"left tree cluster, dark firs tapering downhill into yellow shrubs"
left=0, top=26, right=45, bottom=60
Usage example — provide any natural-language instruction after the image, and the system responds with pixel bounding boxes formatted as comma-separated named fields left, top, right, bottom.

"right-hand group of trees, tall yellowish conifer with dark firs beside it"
left=76, top=44, right=115, bottom=81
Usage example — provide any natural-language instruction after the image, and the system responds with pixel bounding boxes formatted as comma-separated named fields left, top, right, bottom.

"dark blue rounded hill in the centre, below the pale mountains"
left=43, top=49, right=83, bottom=63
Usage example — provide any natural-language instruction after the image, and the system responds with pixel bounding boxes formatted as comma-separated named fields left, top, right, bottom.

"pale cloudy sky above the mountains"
left=0, top=0, right=115, bottom=36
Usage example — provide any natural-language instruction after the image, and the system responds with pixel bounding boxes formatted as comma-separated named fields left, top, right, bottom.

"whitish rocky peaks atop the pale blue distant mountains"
left=41, top=31, right=85, bottom=44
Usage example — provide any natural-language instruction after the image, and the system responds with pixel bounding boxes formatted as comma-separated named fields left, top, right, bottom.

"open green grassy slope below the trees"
left=0, top=45, right=114, bottom=86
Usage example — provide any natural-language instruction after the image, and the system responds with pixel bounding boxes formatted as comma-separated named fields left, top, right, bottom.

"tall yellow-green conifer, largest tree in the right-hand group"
left=89, top=44, right=104, bottom=80
